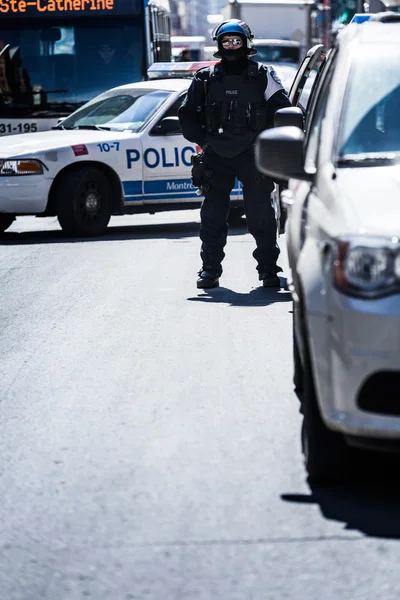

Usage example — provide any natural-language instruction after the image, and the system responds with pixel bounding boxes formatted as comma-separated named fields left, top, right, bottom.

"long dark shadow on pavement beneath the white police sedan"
left=0, top=221, right=247, bottom=246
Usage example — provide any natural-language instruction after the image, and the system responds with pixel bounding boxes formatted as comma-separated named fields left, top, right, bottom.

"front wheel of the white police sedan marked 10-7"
left=56, top=167, right=111, bottom=236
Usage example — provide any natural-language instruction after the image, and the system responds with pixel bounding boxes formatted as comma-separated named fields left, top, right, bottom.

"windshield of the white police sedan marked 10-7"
left=62, top=89, right=172, bottom=132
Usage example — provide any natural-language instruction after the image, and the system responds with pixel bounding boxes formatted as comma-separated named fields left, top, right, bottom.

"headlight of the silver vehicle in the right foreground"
left=333, top=237, right=400, bottom=298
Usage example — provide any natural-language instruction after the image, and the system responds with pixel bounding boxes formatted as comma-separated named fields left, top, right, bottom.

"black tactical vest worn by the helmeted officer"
left=204, top=61, right=267, bottom=158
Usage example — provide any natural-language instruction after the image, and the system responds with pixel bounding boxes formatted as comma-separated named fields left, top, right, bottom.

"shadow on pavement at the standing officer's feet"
left=188, top=277, right=292, bottom=306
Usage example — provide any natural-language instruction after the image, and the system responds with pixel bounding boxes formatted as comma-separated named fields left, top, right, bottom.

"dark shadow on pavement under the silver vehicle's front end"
left=281, top=454, right=400, bottom=539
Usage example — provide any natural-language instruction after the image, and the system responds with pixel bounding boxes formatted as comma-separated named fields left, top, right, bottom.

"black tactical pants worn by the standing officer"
left=200, top=148, right=282, bottom=274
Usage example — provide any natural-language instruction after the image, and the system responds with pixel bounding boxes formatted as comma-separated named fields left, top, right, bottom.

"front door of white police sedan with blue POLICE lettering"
left=142, top=92, right=199, bottom=204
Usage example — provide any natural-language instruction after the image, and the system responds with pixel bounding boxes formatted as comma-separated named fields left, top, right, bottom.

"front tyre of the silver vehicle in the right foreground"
left=301, top=328, right=355, bottom=483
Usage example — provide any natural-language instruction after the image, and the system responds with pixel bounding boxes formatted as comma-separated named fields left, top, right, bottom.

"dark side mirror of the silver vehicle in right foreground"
left=255, top=127, right=314, bottom=181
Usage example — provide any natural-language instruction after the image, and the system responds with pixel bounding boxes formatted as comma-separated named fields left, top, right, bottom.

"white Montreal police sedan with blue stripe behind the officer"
left=0, top=63, right=242, bottom=236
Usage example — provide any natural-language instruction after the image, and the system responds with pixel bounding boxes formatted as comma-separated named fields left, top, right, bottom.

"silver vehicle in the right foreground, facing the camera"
left=256, top=15, right=400, bottom=481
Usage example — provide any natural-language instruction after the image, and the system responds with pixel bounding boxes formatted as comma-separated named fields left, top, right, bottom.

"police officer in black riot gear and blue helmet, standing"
left=178, top=19, right=290, bottom=288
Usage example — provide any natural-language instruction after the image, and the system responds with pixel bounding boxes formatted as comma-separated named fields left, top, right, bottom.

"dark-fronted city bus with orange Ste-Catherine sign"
left=0, top=0, right=171, bottom=135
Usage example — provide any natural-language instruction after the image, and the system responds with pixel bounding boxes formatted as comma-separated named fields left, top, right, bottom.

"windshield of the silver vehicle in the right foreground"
left=339, top=45, right=400, bottom=166
